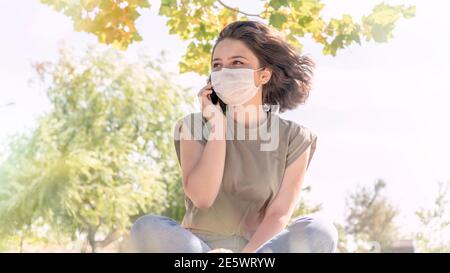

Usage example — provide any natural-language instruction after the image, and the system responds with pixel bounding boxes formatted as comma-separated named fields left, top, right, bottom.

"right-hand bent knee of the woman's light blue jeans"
left=289, top=217, right=338, bottom=252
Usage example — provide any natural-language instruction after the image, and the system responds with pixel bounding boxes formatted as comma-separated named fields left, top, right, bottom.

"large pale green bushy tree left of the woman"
left=0, top=46, right=190, bottom=251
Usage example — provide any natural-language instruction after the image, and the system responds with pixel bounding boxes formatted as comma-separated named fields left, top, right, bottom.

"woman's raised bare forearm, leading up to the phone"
left=185, top=118, right=226, bottom=208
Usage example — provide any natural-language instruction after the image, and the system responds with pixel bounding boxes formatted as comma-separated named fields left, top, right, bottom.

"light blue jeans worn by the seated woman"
left=130, top=214, right=338, bottom=253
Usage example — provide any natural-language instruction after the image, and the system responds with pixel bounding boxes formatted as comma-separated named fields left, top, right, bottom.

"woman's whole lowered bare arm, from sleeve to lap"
left=241, top=147, right=311, bottom=252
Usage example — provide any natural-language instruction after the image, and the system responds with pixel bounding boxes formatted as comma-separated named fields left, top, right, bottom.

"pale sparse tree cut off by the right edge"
left=415, top=182, right=450, bottom=252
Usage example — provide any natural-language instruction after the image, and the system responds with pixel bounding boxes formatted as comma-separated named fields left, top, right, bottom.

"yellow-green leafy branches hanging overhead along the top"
left=41, top=0, right=415, bottom=75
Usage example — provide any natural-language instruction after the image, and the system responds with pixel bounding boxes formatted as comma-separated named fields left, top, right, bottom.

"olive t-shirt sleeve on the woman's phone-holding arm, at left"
left=173, top=112, right=210, bottom=164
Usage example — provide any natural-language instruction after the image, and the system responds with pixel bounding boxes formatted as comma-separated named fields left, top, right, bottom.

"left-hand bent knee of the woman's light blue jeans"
left=130, top=214, right=176, bottom=241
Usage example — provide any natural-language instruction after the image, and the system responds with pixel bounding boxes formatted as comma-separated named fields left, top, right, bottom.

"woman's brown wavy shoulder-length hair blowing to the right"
left=211, top=21, right=315, bottom=113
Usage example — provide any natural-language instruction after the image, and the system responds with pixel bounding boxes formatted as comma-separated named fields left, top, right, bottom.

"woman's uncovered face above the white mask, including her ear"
left=211, top=38, right=271, bottom=86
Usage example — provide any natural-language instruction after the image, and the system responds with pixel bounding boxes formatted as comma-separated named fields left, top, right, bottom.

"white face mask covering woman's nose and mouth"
left=211, top=67, right=262, bottom=105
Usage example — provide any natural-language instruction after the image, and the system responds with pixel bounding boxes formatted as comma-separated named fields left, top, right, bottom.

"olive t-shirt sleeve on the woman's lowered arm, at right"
left=286, top=123, right=317, bottom=169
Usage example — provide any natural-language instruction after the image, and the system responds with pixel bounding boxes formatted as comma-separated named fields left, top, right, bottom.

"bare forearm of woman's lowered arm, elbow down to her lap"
left=241, top=211, right=289, bottom=253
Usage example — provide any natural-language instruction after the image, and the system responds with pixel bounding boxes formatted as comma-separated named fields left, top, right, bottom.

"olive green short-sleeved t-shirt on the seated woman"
left=174, top=112, right=317, bottom=240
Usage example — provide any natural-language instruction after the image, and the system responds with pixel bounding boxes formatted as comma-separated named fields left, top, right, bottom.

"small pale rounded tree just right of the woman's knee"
left=344, top=180, right=398, bottom=251
